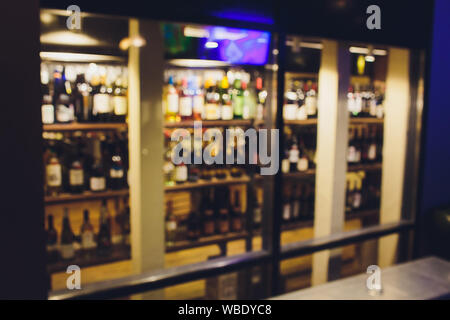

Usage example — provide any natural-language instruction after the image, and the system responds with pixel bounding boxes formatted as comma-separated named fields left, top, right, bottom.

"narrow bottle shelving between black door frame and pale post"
left=281, top=73, right=318, bottom=231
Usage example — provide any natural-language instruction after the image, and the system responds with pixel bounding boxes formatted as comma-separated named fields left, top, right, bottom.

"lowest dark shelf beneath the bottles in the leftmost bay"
left=47, top=245, right=131, bottom=274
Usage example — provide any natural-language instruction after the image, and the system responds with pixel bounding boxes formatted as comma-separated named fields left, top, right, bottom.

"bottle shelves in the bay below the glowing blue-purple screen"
left=163, top=67, right=267, bottom=252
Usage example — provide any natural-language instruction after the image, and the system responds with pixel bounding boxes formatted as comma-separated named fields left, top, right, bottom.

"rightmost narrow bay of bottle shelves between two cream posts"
left=345, top=76, right=385, bottom=225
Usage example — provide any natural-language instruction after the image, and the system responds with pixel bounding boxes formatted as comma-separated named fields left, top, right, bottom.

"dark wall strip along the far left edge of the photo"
left=0, top=0, right=47, bottom=299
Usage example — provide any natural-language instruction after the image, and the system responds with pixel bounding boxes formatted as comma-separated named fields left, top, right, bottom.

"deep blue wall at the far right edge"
left=418, top=0, right=450, bottom=254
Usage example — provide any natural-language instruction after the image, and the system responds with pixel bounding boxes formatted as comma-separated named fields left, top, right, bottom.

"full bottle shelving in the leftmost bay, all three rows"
left=41, top=61, right=130, bottom=273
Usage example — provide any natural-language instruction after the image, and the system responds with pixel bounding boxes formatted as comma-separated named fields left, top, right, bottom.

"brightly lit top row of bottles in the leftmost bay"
left=41, top=63, right=128, bottom=124
